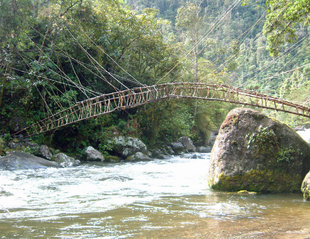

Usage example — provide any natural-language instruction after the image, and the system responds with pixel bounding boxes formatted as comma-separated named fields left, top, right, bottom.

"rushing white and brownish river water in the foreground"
left=0, top=154, right=310, bottom=238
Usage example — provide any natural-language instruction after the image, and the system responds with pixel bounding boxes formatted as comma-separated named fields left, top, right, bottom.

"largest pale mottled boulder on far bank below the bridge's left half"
left=109, top=136, right=148, bottom=158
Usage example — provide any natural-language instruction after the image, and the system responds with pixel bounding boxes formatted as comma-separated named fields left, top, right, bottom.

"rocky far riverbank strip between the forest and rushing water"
left=0, top=136, right=211, bottom=170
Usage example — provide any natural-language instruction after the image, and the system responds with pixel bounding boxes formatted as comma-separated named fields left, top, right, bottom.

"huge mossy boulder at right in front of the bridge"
left=209, top=108, right=310, bottom=192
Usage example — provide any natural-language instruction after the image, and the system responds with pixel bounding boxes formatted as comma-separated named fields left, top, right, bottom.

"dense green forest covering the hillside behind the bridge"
left=0, top=0, right=310, bottom=151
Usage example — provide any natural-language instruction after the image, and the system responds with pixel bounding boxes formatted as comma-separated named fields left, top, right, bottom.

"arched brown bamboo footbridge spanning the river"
left=16, top=82, right=310, bottom=136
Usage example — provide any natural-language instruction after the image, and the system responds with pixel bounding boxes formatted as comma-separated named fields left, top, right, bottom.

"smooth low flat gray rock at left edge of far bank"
left=0, top=151, right=59, bottom=170
